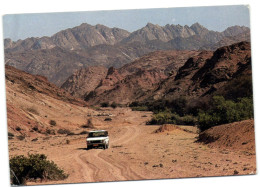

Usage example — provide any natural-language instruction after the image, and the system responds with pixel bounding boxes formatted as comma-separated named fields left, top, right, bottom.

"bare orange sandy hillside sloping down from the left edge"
left=5, top=66, right=91, bottom=138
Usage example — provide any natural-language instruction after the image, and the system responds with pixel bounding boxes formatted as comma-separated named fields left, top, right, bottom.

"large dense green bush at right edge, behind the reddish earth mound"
left=198, top=96, right=254, bottom=131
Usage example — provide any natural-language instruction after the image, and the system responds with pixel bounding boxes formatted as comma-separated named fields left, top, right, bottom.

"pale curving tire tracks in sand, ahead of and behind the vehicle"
left=74, top=125, right=143, bottom=182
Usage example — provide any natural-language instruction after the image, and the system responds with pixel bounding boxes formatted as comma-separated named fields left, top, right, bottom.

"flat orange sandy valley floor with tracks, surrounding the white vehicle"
left=9, top=111, right=256, bottom=185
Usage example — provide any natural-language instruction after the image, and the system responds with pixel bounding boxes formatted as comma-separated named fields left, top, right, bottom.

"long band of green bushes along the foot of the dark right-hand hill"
left=145, top=96, right=254, bottom=131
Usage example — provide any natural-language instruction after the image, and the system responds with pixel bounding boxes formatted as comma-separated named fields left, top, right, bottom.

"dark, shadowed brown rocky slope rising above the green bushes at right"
left=147, top=42, right=252, bottom=101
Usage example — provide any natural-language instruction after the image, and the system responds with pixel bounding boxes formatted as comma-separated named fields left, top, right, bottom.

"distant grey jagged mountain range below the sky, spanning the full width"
left=4, top=23, right=250, bottom=86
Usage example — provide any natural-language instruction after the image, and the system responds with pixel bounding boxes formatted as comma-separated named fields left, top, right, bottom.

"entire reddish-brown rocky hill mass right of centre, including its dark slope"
left=80, top=42, right=251, bottom=104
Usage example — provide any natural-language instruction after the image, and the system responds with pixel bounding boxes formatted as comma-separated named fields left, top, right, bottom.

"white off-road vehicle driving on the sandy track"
left=87, top=130, right=109, bottom=149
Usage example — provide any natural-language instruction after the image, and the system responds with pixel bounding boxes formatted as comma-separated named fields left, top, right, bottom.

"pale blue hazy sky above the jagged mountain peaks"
left=3, top=5, right=250, bottom=41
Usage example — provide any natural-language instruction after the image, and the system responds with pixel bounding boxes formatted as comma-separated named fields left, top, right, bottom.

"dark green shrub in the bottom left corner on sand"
left=9, top=154, right=68, bottom=185
